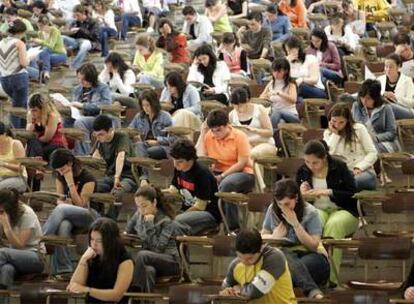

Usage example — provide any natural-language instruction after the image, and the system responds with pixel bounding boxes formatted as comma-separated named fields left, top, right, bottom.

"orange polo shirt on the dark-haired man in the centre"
left=204, top=127, right=253, bottom=174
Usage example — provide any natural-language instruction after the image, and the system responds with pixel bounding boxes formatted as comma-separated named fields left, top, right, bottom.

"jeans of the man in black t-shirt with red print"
left=175, top=211, right=218, bottom=235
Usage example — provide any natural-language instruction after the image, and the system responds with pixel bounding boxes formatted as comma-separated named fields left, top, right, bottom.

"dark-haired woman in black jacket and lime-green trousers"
left=296, top=140, right=358, bottom=283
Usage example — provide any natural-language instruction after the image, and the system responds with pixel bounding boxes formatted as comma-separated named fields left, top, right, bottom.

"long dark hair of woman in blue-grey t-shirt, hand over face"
left=273, top=178, right=305, bottom=224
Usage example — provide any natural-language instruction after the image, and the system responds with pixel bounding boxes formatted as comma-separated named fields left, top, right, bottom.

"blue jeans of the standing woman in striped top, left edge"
left=1, top=72, right=29, bottom=129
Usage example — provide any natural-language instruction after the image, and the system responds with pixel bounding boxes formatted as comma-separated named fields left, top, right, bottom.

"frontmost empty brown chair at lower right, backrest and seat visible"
left=348, top=237, right=412, bottom=293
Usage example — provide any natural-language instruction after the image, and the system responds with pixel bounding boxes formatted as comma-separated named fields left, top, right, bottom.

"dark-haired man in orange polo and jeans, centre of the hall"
left=196, top=110, right=255, bottom=230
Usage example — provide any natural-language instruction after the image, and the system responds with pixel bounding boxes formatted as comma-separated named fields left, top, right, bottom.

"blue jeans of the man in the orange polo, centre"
left=218, top=172, right=255, bottom=230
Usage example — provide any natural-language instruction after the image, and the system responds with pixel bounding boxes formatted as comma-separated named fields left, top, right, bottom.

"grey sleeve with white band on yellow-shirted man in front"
left=240, top=250, right=286, bottom=299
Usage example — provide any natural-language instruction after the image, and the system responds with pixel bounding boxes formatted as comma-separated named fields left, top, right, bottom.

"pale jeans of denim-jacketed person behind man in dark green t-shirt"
left=73, top=116, right=120, bottom=155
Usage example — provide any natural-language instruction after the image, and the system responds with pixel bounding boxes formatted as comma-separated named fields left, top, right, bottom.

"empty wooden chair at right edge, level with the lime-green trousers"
left=373, top=192, right=414, bottom=238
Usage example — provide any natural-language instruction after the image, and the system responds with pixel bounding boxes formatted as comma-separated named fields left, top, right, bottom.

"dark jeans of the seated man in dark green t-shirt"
left=96, top=176, right=137, bottom=221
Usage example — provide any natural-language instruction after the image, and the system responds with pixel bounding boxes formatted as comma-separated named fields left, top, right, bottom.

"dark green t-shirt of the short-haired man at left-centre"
left=98, top=132, right=135, bottom=178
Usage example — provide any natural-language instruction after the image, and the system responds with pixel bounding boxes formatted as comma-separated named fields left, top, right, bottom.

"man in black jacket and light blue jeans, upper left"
left=63, top=5, right=99, bottom=70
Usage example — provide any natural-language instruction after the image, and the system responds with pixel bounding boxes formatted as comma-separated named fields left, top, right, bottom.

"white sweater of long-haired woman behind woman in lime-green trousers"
left=323, top=123, right=378, bottom=171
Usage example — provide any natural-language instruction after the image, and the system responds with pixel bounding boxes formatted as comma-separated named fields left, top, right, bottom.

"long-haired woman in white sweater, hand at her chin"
left=323, top=103, right=378, bottom=191
